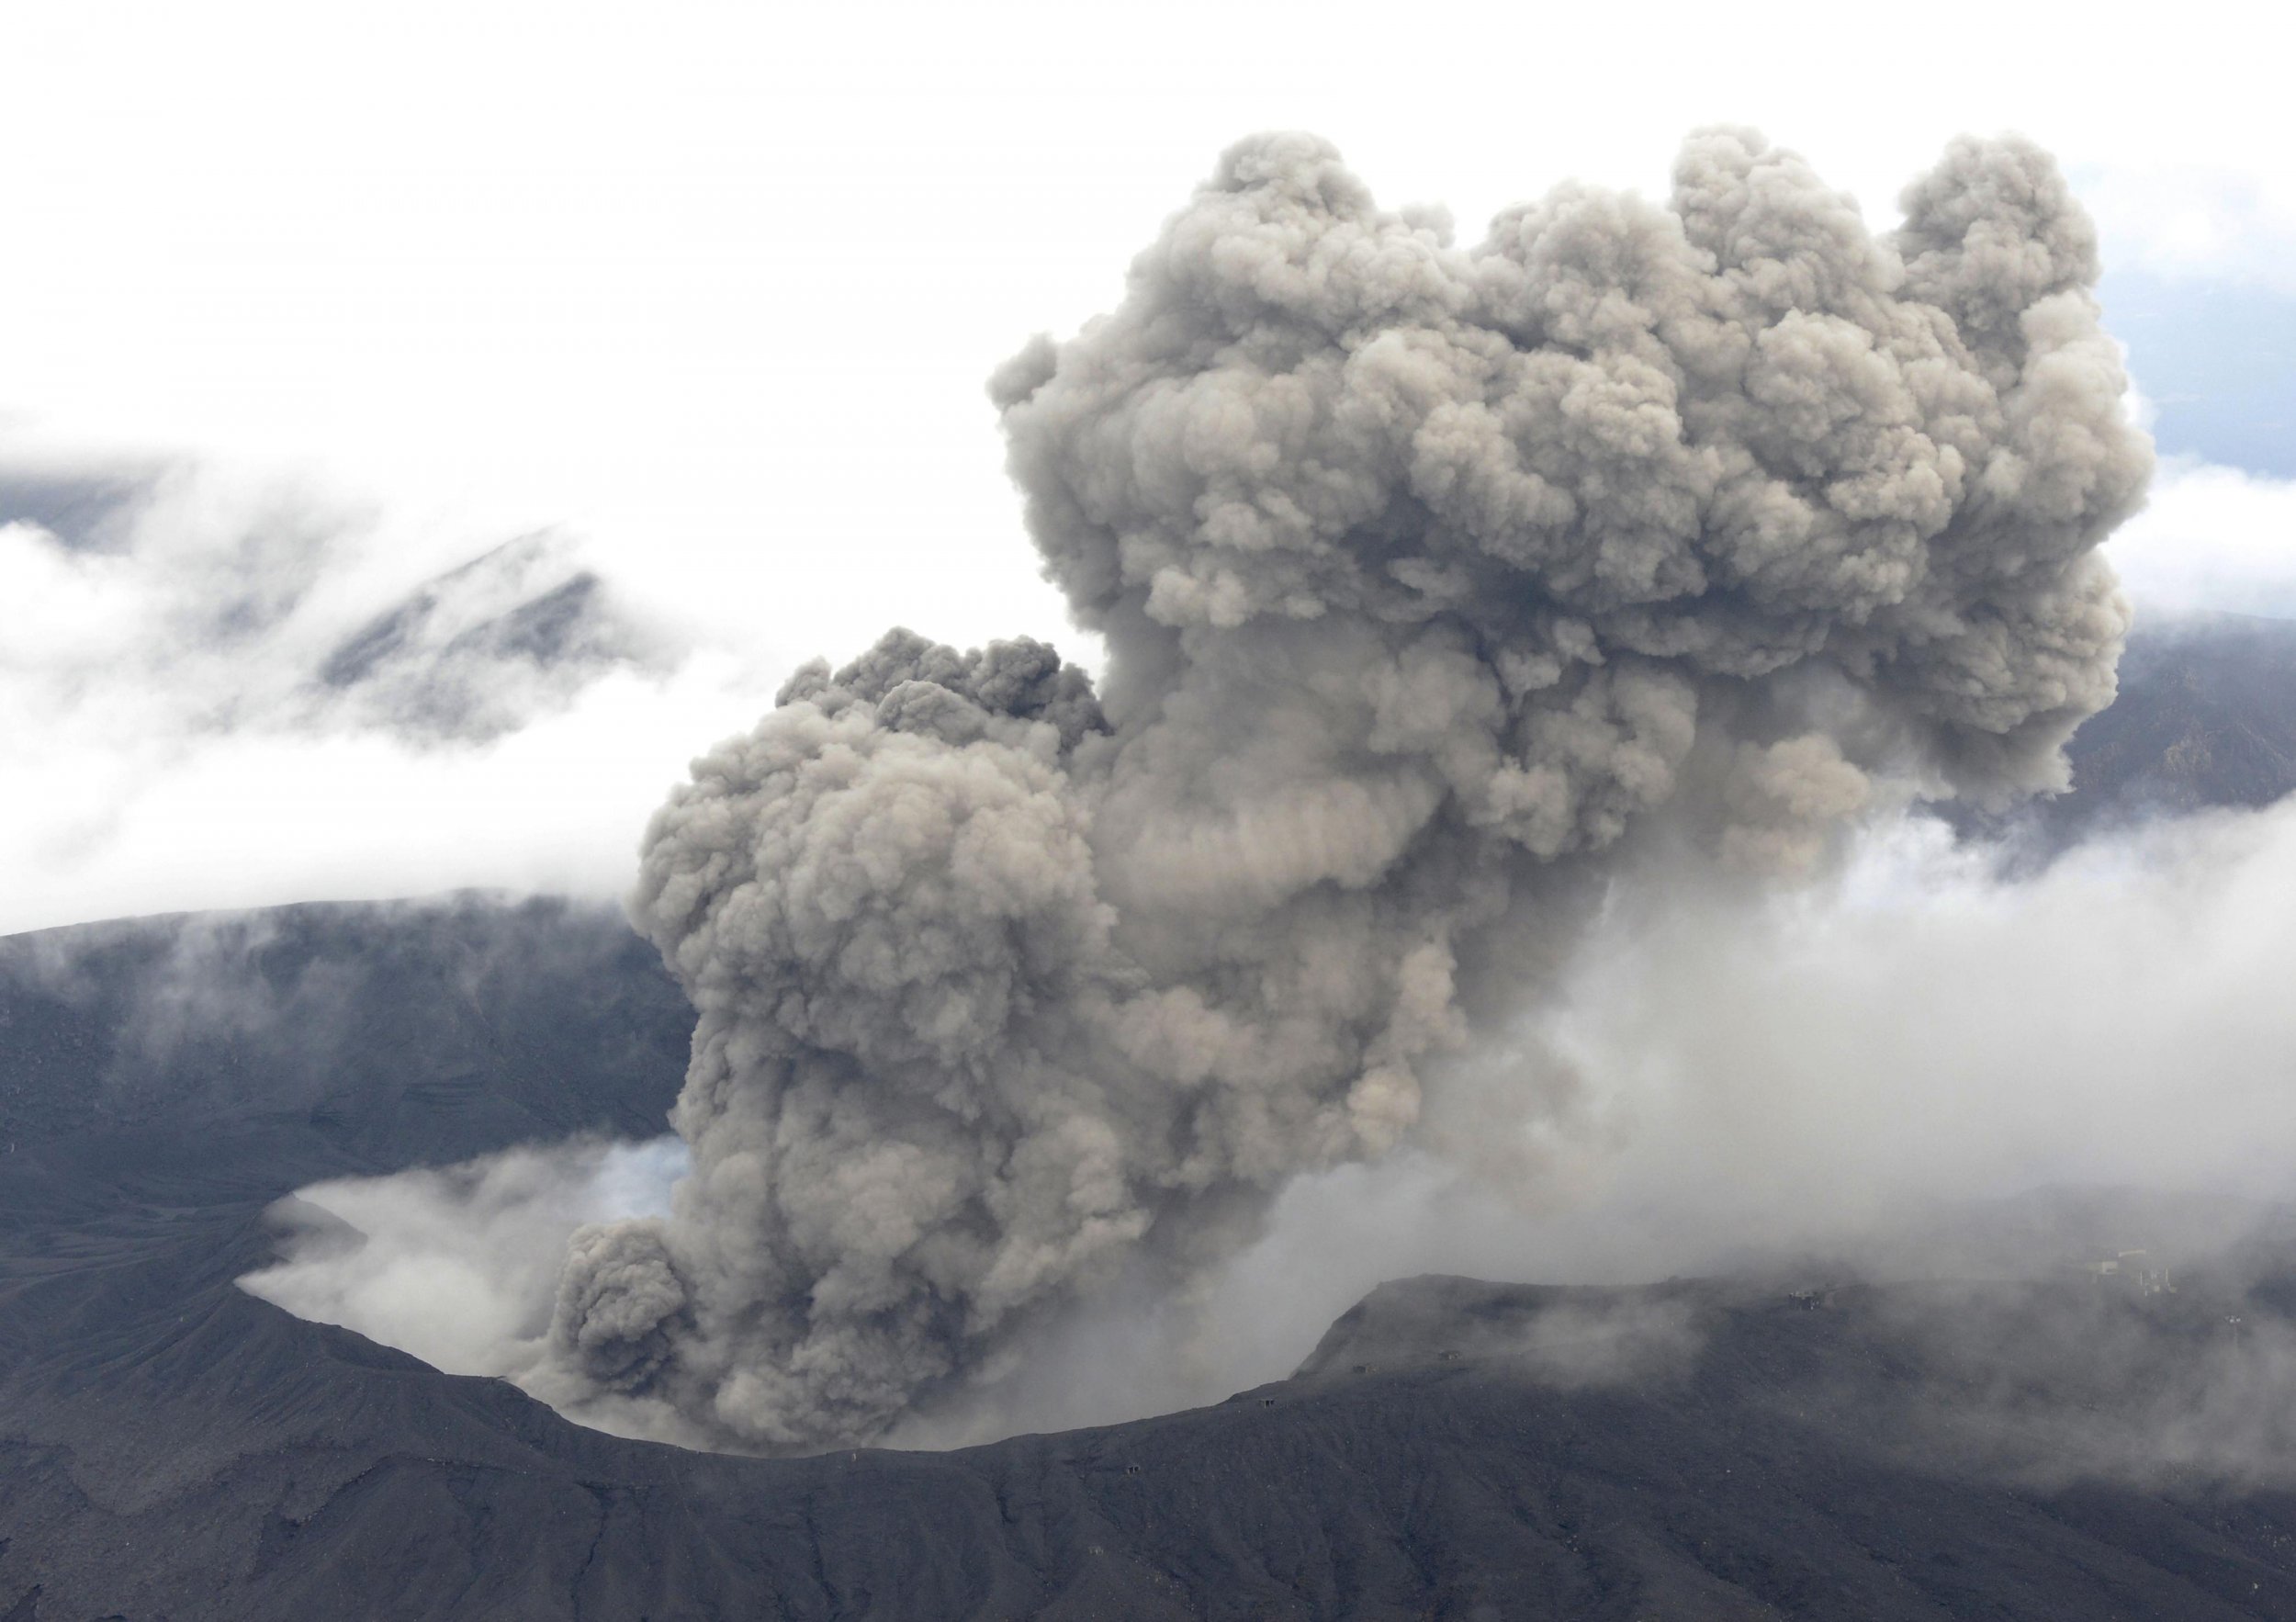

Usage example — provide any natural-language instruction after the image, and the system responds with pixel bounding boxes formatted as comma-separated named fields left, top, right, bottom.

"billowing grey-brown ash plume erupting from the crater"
left=554, top=131, right=2149, bottom=1447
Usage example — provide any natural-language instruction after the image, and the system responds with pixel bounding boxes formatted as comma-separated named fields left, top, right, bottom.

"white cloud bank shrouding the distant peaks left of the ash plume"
left=0, top=441, right=765, bottom=933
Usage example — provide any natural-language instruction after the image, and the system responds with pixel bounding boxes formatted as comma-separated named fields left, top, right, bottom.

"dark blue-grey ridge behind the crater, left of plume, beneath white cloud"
left=0, top=898, right=693, bottom=1157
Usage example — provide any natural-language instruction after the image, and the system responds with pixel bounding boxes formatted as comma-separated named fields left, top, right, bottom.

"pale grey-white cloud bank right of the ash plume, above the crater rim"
left=1261, top=804, right=2296, bottom=1298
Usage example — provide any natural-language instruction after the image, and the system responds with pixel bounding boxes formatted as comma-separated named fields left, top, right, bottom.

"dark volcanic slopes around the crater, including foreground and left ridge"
left=13, top=906, right=2296, bottom=1622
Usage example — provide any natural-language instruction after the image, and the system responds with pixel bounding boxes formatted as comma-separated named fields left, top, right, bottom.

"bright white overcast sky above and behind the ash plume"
left=0, top=0, right=2296, bottom=930
